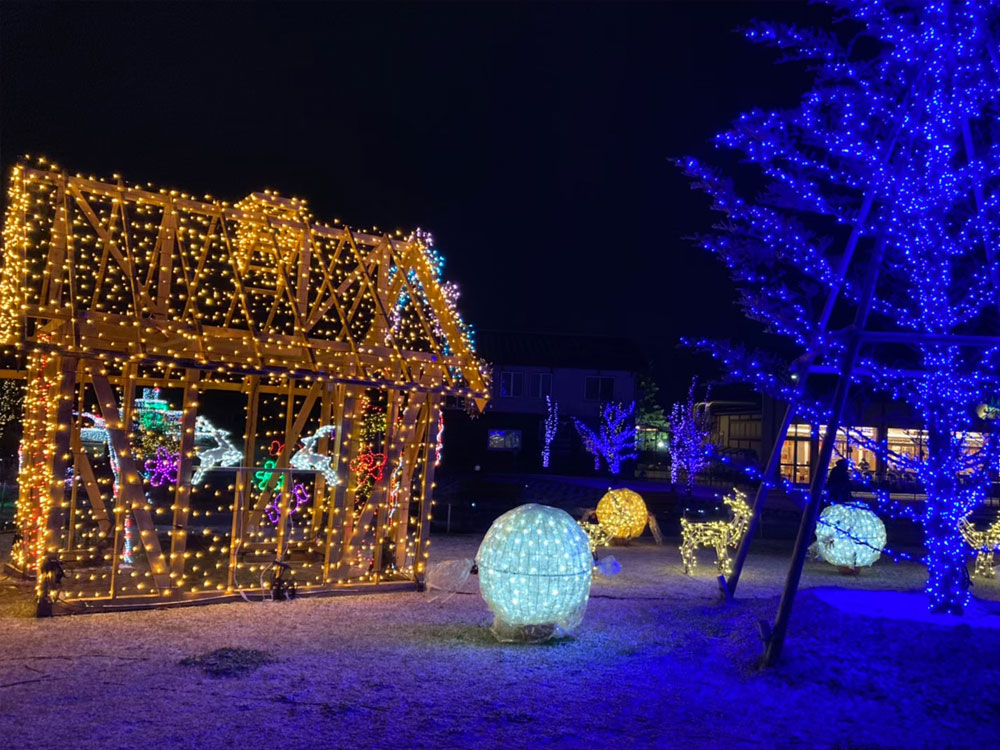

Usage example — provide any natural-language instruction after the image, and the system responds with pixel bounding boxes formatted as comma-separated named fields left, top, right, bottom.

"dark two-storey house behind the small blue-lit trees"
left=444, top=331, right=643, bottom=474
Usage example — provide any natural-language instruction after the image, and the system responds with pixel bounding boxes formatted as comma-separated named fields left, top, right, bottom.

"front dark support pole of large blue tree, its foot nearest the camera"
left=762, top=238, right=885, bottom=667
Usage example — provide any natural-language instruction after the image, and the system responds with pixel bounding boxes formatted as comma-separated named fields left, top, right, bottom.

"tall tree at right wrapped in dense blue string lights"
left=683, top=0, right=1000, bottom=614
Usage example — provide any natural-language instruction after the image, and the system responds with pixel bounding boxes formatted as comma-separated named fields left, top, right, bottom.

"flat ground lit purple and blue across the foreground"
left=0, top=537, right=1000, bottom=750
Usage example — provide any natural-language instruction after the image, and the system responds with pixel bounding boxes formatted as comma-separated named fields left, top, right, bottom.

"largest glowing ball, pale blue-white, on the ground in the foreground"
left=476, top=503, right=594, bottom=642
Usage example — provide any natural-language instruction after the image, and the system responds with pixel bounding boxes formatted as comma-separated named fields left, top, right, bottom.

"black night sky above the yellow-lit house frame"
left=0, top=0, right=828, bottom=399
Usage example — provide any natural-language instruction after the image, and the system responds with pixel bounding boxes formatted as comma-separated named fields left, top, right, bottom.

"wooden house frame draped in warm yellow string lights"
left=0, top=163, right=488, bottom=612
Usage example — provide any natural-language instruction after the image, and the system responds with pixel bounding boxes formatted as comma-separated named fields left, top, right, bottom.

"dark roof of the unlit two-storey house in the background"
left=476, top=331, right=645, bottom=373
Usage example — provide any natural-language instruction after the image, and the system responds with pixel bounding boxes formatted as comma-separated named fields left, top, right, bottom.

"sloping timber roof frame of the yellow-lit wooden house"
left=14, top=168, right=488, bottom=403
